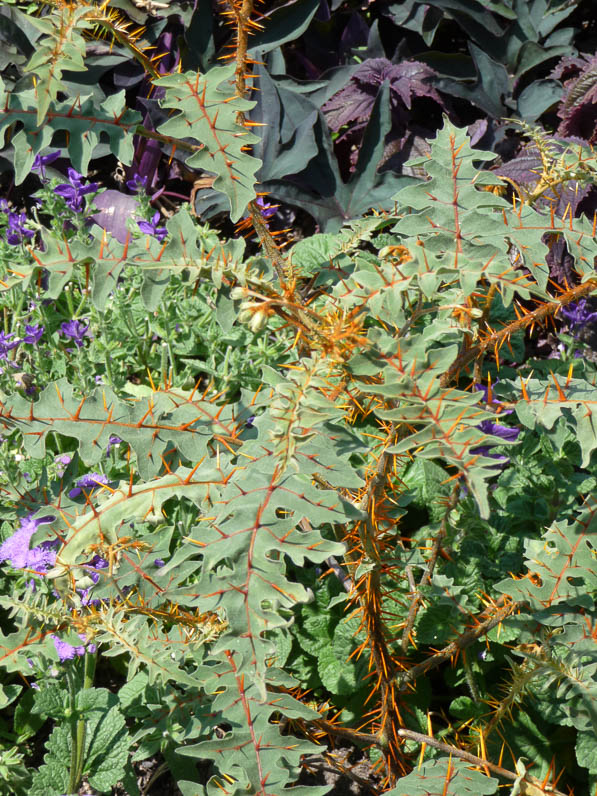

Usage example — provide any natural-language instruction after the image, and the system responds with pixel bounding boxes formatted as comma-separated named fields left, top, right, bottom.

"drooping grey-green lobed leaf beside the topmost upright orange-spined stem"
left=155, top=64, right=261, bottom=222
